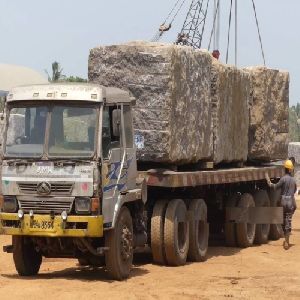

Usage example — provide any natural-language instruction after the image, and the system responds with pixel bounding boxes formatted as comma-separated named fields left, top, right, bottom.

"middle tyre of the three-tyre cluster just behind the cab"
left=164, top=199, right=189, bottom=266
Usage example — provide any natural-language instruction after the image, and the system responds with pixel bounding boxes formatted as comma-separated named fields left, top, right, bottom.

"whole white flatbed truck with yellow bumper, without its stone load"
left=0, top=83, right=284, bottom=280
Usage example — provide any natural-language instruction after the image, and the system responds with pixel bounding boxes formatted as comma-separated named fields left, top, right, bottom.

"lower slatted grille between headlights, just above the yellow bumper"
left=17, top=196, right=75, bottom=214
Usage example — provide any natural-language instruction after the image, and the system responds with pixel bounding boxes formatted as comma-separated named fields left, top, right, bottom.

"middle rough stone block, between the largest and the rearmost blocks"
left=211, top=59, right=250, bottom=163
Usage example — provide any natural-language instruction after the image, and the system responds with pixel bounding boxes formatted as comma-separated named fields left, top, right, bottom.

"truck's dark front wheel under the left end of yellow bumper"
left=12, top=236, right=42, bottom=276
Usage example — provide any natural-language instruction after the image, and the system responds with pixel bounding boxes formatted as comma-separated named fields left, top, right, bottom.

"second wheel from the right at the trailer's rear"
left=254, top=190, right=270, bottom=245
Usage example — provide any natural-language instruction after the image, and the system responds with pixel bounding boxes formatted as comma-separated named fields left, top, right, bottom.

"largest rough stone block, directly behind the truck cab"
left=89, top=42, right=213, bottom=164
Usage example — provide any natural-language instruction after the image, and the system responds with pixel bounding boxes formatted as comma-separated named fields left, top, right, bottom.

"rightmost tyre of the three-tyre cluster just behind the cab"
left=188, top=199, right=209, bottom=262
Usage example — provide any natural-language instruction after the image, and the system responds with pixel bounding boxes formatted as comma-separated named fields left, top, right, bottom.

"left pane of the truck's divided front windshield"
left=5, top=106, right=48, bottom=157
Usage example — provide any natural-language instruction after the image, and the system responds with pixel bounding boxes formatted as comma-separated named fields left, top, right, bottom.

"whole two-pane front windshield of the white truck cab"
left=5, top=105, right=97, bottom=158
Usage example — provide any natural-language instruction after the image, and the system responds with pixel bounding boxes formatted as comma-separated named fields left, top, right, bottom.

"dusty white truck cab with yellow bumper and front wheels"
left=0, top=84, right=142, bottom=279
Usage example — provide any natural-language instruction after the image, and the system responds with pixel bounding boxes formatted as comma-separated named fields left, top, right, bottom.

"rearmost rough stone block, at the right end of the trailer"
left=245, top=67, right=289, bottom=161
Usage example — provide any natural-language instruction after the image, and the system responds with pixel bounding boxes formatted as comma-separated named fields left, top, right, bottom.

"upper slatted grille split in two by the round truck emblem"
left=18, top=182, right=73, bottom=195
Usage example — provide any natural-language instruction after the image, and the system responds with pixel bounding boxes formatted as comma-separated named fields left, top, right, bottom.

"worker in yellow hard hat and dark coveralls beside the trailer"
left=266, top=159, right=297, bottom=250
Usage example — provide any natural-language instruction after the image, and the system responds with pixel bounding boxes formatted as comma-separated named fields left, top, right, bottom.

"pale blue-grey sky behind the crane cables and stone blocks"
left=0, top=0, right=300, bottom=105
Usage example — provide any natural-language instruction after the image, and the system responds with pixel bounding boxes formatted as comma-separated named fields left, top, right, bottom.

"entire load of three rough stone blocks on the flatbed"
left=89, top=42, right=289, bottom=165
